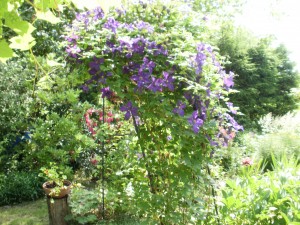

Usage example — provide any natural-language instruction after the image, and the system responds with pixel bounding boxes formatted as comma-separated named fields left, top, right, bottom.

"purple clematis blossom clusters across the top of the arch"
left=65, top=3, right=243, bottom=145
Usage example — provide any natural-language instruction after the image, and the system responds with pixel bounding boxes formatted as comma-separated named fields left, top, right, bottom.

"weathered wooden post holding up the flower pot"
left=47, top=195, right=70, bottom=225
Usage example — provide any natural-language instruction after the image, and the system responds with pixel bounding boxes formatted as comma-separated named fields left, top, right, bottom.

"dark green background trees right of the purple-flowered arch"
left=218, top=26, right=298, bottom=128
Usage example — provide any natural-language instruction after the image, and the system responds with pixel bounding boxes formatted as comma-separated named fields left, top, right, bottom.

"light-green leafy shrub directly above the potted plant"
left=23, top=58, right=93, bottom=169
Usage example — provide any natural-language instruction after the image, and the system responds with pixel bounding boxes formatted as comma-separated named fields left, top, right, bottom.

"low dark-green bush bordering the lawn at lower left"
left=0, top=172, right=44, bottom=206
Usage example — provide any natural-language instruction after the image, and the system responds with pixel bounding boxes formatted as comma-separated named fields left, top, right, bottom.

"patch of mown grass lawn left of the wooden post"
left=0, top=198, right=49, bottom=225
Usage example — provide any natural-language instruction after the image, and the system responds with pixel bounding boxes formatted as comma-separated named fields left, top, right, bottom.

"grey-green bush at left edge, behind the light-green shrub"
left=0, top=59, right=34, bottom=170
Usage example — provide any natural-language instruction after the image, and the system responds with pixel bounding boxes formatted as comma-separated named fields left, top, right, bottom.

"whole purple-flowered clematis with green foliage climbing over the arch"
left=65, top=3, right=243, bottom=224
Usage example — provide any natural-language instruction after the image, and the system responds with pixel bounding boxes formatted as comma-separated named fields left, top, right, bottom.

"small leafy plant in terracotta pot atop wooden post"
left=41, top=163, right=72, bottom=198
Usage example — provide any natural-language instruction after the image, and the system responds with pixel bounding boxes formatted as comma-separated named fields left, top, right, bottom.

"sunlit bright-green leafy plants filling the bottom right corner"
left=220, top=158, right=300, bottom=225
